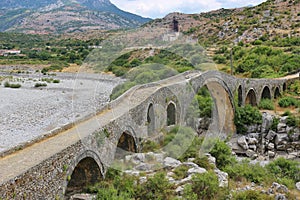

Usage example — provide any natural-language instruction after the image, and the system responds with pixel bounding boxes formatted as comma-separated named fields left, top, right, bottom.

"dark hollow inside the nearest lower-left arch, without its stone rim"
left=65, top=157, right=102, bottom=197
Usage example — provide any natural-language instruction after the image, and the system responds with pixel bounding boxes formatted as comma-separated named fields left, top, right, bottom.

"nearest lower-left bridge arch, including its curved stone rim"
left=65, top=151, right=104, bottom=197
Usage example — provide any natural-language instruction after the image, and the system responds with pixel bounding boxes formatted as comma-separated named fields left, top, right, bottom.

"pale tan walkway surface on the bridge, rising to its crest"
left=0, top=73, right=200, bottom=184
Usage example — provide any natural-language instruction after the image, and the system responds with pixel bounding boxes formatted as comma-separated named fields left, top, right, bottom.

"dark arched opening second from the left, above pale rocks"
left=115, top=132, right=137, bottom=159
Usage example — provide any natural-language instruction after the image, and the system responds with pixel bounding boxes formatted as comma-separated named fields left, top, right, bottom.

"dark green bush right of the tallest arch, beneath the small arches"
left=234, top=105, right=262, bottom=134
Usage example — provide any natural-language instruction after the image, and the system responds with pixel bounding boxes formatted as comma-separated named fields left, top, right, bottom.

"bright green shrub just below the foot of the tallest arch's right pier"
left=210, top=140, right=236, bottom=169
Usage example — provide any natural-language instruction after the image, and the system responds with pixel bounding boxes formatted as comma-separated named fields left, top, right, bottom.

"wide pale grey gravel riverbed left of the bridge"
left=0, top=72, right=124, bottom=153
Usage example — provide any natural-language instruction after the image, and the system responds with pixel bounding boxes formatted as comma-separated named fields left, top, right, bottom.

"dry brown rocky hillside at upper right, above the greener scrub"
left=147, top=0, right=300, bottom=44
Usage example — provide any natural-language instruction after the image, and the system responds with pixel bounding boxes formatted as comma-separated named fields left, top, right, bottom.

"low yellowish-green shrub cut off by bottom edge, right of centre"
left=232, top=190, right=274, bottom=200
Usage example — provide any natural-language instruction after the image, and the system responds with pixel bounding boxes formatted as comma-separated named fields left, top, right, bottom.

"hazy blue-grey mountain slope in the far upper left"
left=0, top=0, right=150, bottom=34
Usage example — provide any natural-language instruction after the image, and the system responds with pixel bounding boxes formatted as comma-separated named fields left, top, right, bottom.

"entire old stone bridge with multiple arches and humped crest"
left=0, top=71, right=288, bottom=199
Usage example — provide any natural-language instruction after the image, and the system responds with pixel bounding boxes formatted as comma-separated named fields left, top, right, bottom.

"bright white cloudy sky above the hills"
left=111, top=0, right=266, bottom=18
